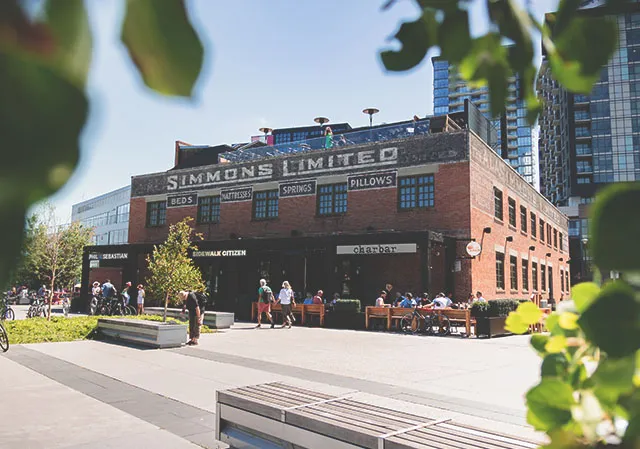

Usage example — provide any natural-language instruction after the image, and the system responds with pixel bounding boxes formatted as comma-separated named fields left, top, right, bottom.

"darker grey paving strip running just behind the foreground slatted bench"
left=168, top=348, right=528, bottom=426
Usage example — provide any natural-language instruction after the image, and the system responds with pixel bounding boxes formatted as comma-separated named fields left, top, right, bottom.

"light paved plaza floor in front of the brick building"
left=0, top=323, right=541, bottom=449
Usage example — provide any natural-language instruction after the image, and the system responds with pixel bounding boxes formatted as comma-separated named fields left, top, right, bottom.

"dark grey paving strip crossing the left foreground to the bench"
left=2, top=345, right=219, bottom=448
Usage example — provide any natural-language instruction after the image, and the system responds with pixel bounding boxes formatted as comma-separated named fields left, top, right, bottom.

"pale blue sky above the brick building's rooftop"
left=51, top=0, right=557, bottom=221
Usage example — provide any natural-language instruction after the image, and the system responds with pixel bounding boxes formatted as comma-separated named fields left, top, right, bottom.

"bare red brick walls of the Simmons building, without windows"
left=122, top=131, right=568, bottom=300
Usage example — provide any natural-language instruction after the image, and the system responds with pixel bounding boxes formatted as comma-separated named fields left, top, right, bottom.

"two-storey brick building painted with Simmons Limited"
left=83, top=106, right=568, bottom=315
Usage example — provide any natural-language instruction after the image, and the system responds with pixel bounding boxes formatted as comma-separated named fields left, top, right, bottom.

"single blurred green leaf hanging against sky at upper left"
left=121, top=0, right=204, bottom=97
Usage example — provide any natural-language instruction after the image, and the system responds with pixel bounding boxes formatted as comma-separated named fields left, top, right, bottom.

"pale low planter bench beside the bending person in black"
left=98, top=318, right=187, bottom=348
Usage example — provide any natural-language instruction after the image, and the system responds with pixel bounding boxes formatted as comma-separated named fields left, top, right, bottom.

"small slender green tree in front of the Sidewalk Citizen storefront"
left=146, top=217, right=205, bottom=321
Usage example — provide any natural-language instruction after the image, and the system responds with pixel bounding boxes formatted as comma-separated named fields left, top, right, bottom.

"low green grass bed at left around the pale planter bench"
left=4, top=315, right=214, bottom=345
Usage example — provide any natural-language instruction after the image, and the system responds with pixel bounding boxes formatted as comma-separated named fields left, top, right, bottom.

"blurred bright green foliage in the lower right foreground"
left=506, top=183, right=640, bottom=449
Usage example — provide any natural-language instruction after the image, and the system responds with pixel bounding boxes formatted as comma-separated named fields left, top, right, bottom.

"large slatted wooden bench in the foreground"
left=215, top=382, right=538, bottom=449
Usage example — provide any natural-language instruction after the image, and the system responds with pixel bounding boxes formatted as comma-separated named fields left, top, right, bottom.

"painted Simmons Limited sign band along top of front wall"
left=131, top=133, right=468, bottom=198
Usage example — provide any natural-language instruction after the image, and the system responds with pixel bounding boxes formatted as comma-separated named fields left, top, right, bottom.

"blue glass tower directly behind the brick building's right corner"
left=432, top=57, right=538, bottom=186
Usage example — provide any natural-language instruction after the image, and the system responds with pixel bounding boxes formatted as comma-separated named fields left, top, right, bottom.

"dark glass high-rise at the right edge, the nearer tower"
left=538, top=1, right=640, bottom=282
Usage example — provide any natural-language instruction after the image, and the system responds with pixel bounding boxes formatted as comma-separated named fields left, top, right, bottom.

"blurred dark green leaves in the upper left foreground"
left=0, top=0, right=204, bottom=285
